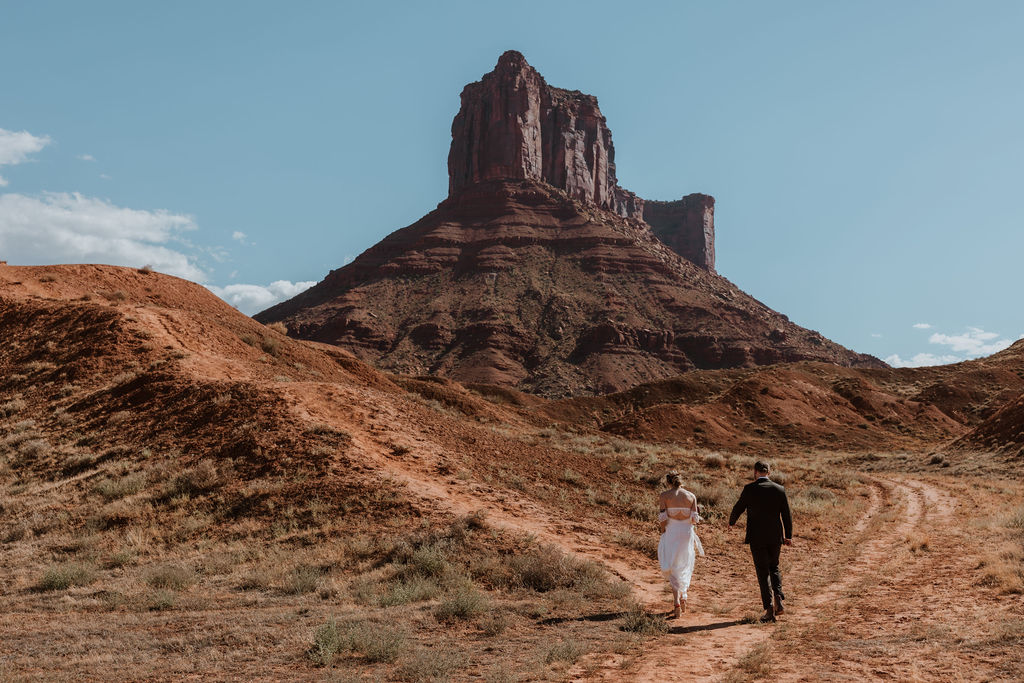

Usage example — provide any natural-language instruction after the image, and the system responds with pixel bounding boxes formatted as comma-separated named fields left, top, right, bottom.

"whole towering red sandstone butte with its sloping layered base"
left=256, top=52, right=885, bottom=397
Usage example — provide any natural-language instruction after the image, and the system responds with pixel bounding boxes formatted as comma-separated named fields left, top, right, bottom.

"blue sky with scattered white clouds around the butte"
left=0, top=0, right=1024, bottom=365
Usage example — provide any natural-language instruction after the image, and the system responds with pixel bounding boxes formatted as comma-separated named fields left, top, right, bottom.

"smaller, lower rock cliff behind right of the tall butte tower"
left=643, top=195, right=715, bottom=272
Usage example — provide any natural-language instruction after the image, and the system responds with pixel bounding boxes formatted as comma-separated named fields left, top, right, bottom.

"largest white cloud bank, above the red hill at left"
left=0, top=193, right=207, bottom=282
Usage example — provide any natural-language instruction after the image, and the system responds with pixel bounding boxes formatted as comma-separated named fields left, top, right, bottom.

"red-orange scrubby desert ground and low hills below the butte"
left=0, top=265, right=1024, bottom=681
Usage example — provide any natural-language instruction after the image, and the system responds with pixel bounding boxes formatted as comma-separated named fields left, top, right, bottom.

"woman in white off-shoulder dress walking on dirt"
left=657, top=472, right=703, bottom=618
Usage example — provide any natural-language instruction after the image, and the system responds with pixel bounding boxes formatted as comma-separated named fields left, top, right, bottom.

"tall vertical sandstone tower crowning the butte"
left=449, top=50, right=643, bottom=218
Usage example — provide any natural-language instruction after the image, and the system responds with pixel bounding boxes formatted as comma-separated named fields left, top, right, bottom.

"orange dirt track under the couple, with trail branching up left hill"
left=274, top=383, right=1015, bottom=682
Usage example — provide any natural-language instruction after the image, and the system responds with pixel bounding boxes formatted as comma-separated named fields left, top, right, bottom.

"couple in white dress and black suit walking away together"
left=657, top=461, right=793, bottom=622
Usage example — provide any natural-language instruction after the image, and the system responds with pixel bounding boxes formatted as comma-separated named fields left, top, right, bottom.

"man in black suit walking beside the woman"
left=729, top=460, right=793, bottom=622
